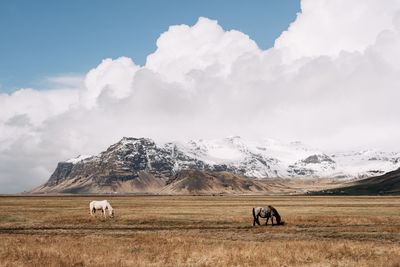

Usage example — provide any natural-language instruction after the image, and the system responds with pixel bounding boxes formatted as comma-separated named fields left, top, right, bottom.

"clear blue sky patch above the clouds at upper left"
left=0, top=0, right=300, bottom=93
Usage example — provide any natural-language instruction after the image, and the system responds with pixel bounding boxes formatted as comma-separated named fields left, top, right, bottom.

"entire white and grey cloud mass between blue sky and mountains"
left=0, top=0, right=400, bottom=193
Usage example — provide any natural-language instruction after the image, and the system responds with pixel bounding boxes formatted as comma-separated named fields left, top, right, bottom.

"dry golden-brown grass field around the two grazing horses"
left=0, top=196, right=400, bottom=266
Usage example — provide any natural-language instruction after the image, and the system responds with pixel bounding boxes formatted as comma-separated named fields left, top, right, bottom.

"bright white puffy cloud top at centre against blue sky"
left=146, top=17, right=260, bottom=85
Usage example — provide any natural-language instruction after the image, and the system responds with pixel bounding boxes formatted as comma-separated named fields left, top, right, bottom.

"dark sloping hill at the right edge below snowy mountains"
left=320, top=168, right=400, bottom=195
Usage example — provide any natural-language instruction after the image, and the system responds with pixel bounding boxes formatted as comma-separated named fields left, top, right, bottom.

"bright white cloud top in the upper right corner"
left=275, top=0, right=400, bottom=60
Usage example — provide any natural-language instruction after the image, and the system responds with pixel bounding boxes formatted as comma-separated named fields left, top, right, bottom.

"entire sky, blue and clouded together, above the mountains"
left=0, top=0, right=400, bottom=193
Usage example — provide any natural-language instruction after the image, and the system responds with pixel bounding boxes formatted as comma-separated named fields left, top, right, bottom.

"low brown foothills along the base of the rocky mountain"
left=30, top=170, right=276, bottom=195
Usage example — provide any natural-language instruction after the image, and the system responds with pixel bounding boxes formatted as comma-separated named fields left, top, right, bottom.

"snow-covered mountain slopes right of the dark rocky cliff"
left=169, top=137, right=400, bottom=178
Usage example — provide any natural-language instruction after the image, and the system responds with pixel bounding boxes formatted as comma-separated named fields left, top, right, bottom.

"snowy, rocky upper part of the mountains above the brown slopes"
left=55, top=137, right=400, bottom=183
